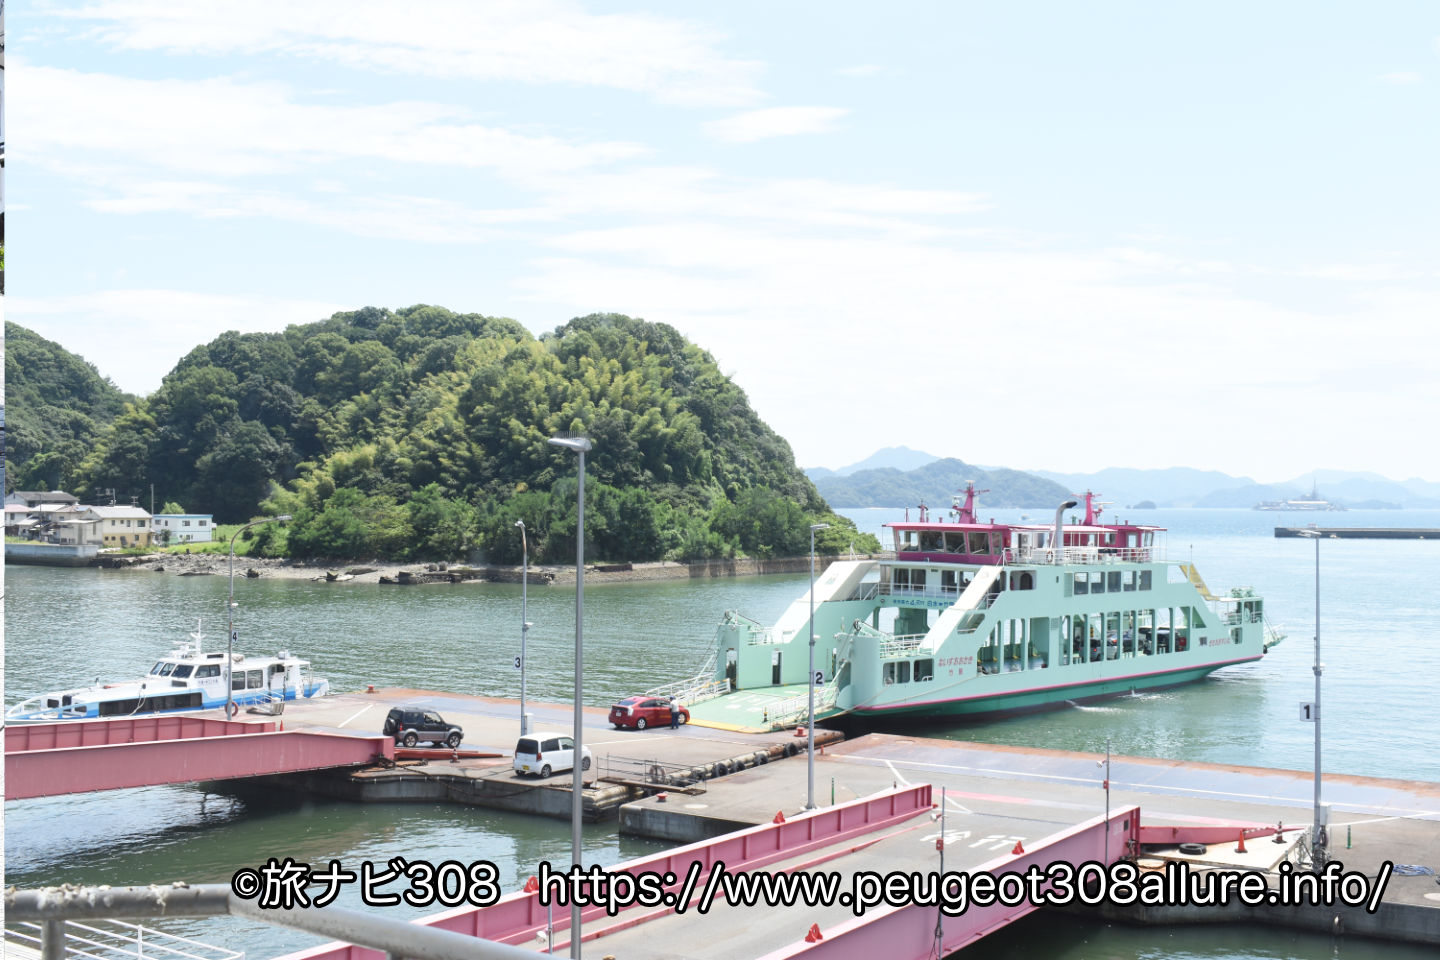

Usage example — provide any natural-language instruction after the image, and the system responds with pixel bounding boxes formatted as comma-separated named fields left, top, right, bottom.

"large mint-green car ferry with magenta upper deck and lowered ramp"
left=682, top=485, right=1283, bottom=730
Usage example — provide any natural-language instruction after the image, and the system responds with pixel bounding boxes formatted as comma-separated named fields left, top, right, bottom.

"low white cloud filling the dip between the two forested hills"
left=6, top=289, right=356, bottom=394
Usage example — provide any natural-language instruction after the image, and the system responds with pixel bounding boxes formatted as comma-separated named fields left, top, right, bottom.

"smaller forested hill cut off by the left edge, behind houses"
left=4, top=321, right=134, bottom=489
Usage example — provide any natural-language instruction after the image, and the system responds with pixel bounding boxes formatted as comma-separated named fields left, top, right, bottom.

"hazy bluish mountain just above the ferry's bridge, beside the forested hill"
left=812, top=450, right=1070, bottom=512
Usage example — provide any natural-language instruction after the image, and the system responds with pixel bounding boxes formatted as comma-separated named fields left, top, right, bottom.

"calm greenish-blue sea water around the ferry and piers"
left=4, top=508, right=1440, bottom=960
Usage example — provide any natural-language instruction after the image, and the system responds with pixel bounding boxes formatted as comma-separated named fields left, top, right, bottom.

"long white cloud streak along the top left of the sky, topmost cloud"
left=46, top=0, right=763, bottom=107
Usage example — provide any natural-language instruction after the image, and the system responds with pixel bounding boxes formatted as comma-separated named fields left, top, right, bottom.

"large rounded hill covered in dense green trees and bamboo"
left=50, top=305, right=865, bottom=563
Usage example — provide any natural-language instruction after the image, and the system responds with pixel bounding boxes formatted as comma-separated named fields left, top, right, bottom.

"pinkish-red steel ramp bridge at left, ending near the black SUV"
left=4, top=715, right=395, bottom=800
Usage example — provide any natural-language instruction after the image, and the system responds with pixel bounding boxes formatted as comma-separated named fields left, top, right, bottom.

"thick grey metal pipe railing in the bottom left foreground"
left=4, top=884, right=536, bottom=960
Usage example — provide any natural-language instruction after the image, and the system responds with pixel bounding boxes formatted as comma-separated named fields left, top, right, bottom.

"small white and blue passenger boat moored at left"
left=4, top=626, right=330, bottom=723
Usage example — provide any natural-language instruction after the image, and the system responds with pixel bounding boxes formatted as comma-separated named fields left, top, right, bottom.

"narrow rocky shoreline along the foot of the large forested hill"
left=99, top=554, right=878, bottom=586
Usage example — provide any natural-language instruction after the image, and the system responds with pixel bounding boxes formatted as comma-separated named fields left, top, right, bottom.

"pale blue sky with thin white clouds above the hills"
left=4, top=0, right=1440, bottom=482
